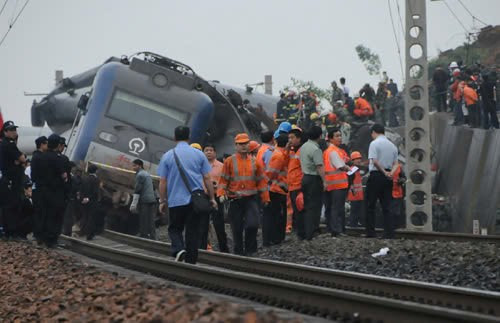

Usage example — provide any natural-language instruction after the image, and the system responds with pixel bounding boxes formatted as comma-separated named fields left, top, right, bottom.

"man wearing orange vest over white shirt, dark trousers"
left=323, top=128, right=350, bottom=237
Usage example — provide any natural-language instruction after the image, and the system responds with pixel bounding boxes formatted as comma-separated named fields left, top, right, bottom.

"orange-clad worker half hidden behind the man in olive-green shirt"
left=287, top=128, right=305, bottom=239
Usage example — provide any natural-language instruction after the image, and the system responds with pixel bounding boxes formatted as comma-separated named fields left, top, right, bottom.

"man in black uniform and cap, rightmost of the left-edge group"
left=32, top=134, right=68, bottom=248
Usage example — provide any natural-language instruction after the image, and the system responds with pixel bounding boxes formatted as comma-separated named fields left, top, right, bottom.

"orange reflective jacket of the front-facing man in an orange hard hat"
left=217, top=153, right=269, bottom=202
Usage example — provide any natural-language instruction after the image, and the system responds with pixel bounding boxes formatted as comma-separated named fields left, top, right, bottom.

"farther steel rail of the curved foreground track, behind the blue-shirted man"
left=103, top=230, right=500, bottom=317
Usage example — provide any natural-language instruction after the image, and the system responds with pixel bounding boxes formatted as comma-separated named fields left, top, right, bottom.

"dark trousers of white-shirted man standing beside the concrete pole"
left=366, top=171, right=394, bottom=238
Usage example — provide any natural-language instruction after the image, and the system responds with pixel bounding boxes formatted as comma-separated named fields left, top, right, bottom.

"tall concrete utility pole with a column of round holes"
left=405, top=0, right=432, bottom=231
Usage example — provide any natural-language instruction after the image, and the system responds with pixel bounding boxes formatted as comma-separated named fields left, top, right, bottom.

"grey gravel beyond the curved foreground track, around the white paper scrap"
left=157, top=225, right=500, bottom=292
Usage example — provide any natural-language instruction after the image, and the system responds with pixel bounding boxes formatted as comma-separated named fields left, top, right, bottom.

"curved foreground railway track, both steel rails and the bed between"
left=60, top=231, right=500, bottom=322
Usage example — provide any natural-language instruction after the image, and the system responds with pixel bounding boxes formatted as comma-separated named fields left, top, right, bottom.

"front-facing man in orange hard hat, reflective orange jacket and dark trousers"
left=217, top=133, right=269, bottom=255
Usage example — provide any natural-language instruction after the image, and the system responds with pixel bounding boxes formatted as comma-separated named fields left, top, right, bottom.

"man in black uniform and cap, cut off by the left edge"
left=0, top=121, right=26, bottom=238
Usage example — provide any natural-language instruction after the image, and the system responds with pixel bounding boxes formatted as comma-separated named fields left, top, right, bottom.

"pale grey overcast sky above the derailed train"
left=0, top=0, right=500, bottom=125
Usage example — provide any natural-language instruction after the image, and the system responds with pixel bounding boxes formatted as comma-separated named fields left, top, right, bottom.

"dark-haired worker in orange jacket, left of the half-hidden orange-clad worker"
left=262, top=134, right=288, bottom=246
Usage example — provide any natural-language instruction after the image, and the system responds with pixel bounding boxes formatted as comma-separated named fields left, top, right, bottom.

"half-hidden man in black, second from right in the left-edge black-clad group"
left=30, top=136, right=49, bottom=244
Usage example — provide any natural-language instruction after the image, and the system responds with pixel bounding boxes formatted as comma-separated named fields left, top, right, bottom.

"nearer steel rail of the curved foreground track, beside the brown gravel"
left=61, top=236, right=500, bottom=323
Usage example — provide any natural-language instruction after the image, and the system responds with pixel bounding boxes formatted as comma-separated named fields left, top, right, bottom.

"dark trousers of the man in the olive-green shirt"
left=302, top=174, right=323, bottom=240
